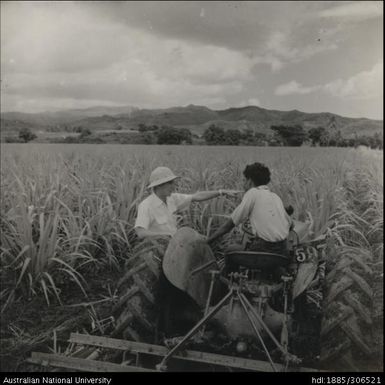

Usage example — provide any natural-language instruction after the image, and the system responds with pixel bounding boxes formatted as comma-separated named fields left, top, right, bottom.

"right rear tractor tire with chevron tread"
left=320, top=246, right=374, bottom=372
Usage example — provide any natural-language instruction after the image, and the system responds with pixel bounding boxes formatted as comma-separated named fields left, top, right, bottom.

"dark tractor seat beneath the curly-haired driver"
left=226, top=250, right=290, bottom=270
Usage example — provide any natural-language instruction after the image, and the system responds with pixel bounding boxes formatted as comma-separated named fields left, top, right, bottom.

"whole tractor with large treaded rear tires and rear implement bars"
left=28, top=214, right=374, bottom=372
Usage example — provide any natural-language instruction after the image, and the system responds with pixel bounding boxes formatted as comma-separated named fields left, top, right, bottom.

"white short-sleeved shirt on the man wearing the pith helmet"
left=135, top=193, right=192, bottom=235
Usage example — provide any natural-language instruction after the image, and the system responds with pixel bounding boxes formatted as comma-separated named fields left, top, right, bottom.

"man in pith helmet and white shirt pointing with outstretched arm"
left=135, top=167, right=229, bottom=238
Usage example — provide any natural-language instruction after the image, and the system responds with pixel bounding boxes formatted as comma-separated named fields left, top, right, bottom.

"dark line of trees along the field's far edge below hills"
left=6, top=123, right=383, bottom=149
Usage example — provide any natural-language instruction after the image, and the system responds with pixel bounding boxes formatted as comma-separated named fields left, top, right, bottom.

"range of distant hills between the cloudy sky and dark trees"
left=1, top=105, right=383, bottom=137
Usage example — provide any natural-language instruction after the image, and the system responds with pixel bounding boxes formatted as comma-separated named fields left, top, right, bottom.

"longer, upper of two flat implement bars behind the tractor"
left=70, top=333, right=300, bottom=372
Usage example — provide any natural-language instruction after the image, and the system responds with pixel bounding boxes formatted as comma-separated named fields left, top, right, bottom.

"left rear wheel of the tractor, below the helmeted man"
left=111, top=243, right=202, bottom=343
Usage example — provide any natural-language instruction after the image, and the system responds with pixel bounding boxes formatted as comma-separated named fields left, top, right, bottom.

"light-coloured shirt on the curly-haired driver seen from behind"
left=231, top=186, right=290, bottom=242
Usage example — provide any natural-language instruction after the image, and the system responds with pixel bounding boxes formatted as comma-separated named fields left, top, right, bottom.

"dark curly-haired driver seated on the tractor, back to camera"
left=208, top=163, right=291, bottom=254
